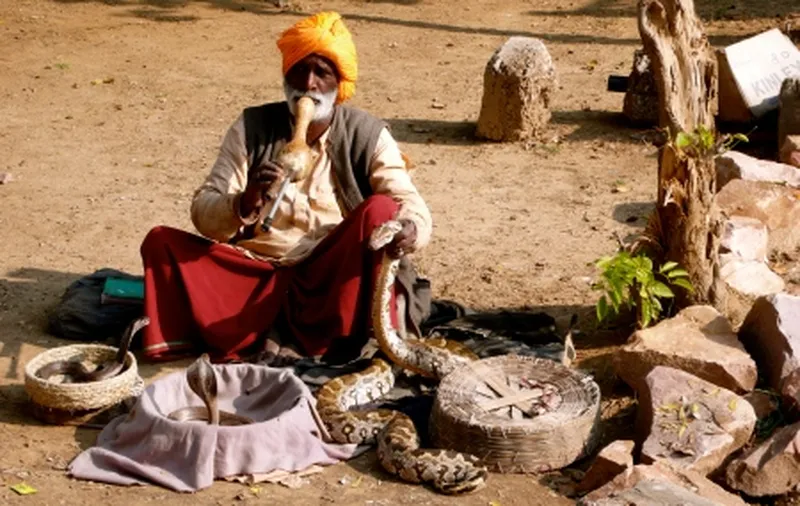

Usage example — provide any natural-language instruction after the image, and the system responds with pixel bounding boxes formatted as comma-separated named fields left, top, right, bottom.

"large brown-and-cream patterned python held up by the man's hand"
left=317, top=221, right=487, bottom=494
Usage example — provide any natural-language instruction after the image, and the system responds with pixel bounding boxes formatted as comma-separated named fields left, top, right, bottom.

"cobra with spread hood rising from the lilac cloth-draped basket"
left=167, top=353, right=254, bottom=426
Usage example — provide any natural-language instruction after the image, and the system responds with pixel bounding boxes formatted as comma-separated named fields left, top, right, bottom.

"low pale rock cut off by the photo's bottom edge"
left=577, top=462, right=747, bottom=506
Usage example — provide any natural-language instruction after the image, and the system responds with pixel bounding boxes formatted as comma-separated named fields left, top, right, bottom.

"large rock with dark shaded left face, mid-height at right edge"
left=739, top=293, right=800, bottom=405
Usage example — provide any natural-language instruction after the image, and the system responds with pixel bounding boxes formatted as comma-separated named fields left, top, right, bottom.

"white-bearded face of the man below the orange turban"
left=283, top=54, right=339, bottom=121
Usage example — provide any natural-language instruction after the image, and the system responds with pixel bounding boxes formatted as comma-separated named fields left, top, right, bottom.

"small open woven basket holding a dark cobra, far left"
left=25, top=344, right=143, bottom=411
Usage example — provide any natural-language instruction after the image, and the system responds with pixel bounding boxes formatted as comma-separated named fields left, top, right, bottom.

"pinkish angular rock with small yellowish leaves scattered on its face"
left=636, top=366, right=756, bottom=476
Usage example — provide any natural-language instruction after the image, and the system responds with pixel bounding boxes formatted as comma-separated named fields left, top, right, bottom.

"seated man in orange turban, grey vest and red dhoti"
left=141, top=13, right=432, bottom=361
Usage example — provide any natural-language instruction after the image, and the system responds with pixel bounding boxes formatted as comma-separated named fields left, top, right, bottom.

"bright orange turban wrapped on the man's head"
left=278, top=12, right=358, bottom=103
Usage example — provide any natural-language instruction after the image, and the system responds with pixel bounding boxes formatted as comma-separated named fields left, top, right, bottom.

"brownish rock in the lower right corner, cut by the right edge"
left=725, top=423, right=800, bottom=497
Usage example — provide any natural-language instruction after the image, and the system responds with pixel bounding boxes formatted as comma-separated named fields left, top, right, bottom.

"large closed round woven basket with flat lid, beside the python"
left=430, top=355, right=600, bottom=473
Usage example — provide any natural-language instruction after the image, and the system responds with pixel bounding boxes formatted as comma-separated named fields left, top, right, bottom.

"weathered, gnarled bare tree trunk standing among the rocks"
left=638, top=0, right=725, bottom=311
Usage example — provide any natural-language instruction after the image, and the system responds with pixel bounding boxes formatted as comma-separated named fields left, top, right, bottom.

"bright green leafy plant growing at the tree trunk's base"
left=592, top=250, right=693, bottom=328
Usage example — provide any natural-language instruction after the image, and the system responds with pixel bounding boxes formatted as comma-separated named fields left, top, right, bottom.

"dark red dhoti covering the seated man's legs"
left=141, top=195, right=397, bottom=361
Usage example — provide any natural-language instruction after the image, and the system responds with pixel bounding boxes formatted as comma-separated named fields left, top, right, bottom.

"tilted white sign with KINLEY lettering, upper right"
left=725, top=28, right=800, bottom=117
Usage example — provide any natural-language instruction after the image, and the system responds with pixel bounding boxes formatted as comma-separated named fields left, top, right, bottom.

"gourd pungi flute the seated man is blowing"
left=261, top=97, right=319, bottom=232
